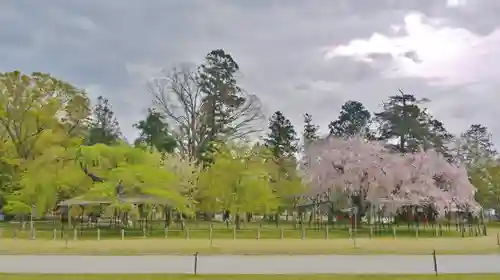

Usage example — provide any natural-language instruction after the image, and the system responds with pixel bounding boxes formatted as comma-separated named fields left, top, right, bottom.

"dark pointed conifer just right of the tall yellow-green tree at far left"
left=87, top=96, right=121, bottom=145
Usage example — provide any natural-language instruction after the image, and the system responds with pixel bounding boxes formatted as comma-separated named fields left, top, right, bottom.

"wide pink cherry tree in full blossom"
left=302, top=136, right=478, bottom=223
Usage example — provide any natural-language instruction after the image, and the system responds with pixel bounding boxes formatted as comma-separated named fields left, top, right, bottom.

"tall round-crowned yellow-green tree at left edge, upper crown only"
left=0, top=71, right=89, bottom=160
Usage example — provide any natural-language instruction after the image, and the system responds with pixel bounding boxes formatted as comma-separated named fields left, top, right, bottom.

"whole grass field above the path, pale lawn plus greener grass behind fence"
left=0, top=222, right=500, bottom=255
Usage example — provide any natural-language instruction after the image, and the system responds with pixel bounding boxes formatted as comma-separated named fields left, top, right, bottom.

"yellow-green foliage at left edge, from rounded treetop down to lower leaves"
left=0, top=71, right=89, bottom=212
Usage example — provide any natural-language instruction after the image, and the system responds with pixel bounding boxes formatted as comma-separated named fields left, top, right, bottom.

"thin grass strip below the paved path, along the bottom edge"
left=0, top=274, right=500, bottom=280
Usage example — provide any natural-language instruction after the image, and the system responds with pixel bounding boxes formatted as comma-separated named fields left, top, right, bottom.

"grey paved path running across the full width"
left=0, top=255, right=500, bottom=274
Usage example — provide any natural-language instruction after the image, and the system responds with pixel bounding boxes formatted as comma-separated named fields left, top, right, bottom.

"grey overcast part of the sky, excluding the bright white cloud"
left=0, top=0, right=500, bottom=144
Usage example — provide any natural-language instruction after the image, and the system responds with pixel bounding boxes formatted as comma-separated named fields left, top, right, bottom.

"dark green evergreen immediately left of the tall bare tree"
left=134, top=109, right=177, bottom=153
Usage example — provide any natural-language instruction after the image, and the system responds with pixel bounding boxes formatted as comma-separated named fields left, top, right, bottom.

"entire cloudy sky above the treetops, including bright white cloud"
left=0, top=0, right=500, bottom=144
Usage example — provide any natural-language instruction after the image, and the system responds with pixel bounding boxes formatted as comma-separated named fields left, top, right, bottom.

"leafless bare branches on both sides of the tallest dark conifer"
left=147, top=64, right=264, bottom=159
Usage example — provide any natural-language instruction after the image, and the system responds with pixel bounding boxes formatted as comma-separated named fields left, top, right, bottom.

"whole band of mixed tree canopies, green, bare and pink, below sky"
left=0, top=49, right=494, bottom=223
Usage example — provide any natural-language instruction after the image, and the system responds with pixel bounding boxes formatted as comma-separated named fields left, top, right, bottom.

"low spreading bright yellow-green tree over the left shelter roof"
left=78, top=144, right=193, bottom=211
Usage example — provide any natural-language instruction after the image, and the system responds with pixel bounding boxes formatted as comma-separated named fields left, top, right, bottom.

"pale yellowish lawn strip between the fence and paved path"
left=0, top=236, right=500, bottom=256
